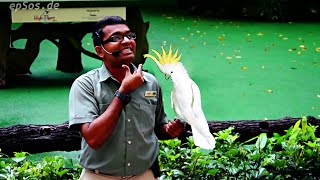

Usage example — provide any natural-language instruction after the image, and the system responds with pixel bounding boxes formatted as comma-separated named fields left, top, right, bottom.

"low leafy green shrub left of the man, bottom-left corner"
left=0, top=152, right=82, bottom=180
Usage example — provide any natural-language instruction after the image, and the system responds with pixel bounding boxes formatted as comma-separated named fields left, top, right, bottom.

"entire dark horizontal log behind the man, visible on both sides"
left=0, top=116, right=320, bottom=156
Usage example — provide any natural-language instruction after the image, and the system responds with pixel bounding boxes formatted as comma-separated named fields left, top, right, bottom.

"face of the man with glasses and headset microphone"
left=98, top=24, right=136, bottom=66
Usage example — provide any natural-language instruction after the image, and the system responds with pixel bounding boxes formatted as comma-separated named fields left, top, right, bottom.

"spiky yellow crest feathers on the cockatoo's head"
left=143, top=46, right=182, bottom=65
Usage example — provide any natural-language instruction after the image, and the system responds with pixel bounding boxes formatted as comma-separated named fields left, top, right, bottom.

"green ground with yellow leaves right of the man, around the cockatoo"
left=144, top=10, right=320, bottom=120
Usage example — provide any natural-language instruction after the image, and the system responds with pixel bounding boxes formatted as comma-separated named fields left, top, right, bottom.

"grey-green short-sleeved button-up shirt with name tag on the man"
left=69, top=64, right=168, bottom=176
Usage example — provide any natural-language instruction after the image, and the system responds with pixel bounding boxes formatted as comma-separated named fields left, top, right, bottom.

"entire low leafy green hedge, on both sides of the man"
left=0, top=117, right=320, bottom=180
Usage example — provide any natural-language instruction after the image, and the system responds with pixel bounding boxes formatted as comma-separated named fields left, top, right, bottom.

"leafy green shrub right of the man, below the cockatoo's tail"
left=159, top=117, right=320, bottom=180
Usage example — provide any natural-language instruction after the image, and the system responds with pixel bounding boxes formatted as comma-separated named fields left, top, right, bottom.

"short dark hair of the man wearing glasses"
left=92, top=16, right=129, bottom=46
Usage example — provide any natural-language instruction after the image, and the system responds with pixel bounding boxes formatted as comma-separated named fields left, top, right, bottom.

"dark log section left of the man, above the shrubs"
left=0, top=123, right=81, bottom=156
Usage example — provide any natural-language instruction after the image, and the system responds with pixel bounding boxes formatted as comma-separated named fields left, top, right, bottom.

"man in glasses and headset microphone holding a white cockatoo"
left=69, top=16, right=184, bottom=180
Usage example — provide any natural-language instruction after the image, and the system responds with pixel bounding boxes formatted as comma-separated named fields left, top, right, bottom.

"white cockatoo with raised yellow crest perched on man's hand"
left=144, top=46, right=216, bottom=150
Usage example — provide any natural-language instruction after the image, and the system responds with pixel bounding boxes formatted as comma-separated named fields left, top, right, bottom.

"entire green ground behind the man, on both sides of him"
left=0, top=9, right=320, bottom=158
